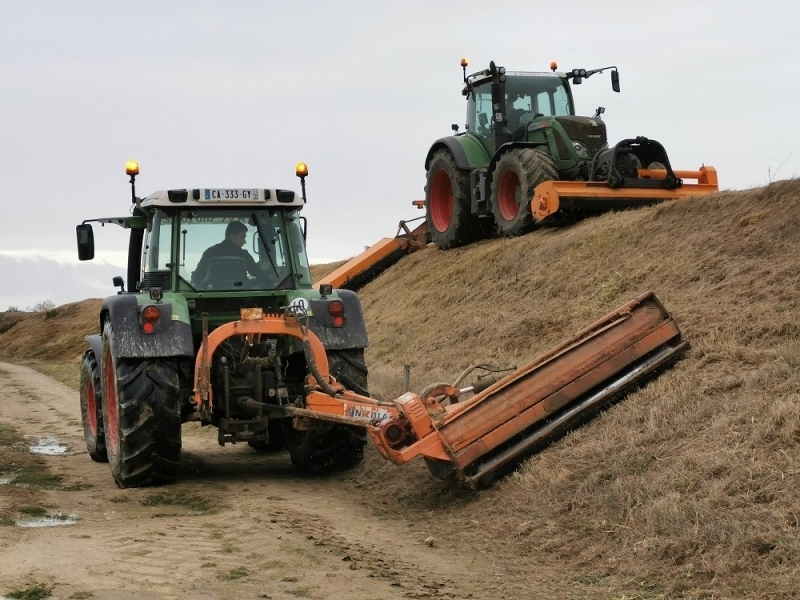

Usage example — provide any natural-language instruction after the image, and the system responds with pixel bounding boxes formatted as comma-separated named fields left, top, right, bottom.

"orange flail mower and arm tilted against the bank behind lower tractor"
left=195, top=292, right=688, bottom=486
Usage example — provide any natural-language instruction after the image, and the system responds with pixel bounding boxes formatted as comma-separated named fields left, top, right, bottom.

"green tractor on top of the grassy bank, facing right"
left=425, top=59, right=682, bottom=249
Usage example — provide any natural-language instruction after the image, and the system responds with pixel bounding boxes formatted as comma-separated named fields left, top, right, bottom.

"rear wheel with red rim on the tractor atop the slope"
left=425, top=150, right=491, bottom=250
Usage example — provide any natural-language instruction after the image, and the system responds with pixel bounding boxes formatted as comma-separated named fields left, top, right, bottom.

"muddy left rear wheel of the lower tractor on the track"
left=102, top=323, right=181, bottom=488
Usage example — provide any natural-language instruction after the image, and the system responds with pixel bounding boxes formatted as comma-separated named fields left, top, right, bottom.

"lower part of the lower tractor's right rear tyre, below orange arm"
left=283, top=419, right=367, bottom=472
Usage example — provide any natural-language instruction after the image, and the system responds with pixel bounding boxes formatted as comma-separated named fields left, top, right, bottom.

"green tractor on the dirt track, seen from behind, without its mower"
left=77, top=162, right=368, bottom=487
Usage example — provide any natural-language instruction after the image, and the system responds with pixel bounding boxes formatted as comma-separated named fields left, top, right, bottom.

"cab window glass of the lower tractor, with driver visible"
left=145, top=209, right=311, bottom=291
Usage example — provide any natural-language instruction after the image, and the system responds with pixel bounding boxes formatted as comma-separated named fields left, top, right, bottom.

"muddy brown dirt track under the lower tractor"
left=0, top=363, right=503, bottom=599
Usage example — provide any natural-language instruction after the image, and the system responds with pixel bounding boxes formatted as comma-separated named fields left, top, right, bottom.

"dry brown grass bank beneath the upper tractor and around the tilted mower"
left=0, top=180, right=800, bottom=598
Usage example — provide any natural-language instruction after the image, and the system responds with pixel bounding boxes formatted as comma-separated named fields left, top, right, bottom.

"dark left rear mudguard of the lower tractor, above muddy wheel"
left=98, top=294, right=194, bottom=358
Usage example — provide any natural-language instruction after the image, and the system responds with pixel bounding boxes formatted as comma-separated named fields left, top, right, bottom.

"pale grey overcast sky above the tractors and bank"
left=0, top=0, right=800, bottom=310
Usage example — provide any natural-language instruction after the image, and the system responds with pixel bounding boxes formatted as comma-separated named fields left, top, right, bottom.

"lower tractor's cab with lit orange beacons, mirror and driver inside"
left=77, top=161, right=312, bottom=297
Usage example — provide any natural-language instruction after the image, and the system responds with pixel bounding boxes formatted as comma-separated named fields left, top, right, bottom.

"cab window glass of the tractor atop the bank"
left=467, top=73, right=575, bottom=137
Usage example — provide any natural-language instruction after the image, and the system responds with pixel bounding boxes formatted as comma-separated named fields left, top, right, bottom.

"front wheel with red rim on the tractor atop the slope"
left=492, top=148, right=558, bottom=236
